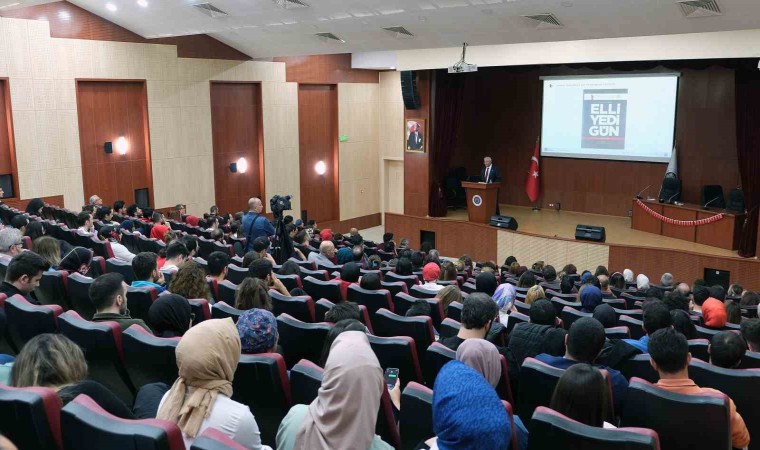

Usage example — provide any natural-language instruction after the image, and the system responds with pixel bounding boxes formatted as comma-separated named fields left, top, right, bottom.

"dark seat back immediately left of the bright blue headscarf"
left=399, top=382, right=435, bottom=450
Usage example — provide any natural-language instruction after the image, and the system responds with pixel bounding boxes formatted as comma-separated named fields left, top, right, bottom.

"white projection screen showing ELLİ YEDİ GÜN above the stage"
left=541, top=73, right=679, bottom=162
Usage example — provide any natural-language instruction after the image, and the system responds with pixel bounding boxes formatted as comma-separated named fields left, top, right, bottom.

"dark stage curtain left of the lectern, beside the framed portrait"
left=428, top=70, right=467, bottom=217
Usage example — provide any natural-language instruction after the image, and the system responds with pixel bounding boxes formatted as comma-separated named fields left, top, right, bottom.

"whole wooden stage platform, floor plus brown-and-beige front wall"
left=384, top=204, right=760, bottom=290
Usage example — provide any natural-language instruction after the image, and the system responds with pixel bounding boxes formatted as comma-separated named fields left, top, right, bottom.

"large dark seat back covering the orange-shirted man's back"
left=621, top=377, right=731, bottom=450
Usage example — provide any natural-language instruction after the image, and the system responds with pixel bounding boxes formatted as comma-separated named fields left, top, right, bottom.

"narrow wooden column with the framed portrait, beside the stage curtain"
left=398, top=70, right=432, bottom=216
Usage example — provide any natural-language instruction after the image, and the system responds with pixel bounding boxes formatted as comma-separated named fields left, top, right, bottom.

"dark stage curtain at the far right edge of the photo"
left=736, top=69, right=760, bottom=258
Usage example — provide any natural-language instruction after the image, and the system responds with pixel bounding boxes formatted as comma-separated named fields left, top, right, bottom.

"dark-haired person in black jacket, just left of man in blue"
left=508, top=299, right=567, bottom=368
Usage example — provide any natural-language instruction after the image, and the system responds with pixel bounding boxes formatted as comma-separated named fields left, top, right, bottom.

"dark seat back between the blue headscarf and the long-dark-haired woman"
left=517, top=358, right=565, bottom=417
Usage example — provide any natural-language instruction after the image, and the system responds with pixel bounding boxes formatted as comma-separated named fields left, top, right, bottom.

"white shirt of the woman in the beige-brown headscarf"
left=158, top=388, right=272, bottom=450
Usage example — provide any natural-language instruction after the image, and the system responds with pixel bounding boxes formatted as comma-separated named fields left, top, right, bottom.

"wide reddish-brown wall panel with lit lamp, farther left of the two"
left=77, top=81, right=155, bottom=206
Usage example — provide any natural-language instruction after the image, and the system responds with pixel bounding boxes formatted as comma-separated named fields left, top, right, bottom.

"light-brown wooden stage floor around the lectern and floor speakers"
left=441, top=205, right=739, bottom=257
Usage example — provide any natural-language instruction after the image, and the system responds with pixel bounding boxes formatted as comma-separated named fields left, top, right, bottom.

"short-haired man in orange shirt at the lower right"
left=649, top=327, right=750, bottom=448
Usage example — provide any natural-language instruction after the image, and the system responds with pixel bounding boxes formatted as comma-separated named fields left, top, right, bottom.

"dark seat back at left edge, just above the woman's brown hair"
left=5, top=295, right=63, bottom=351
